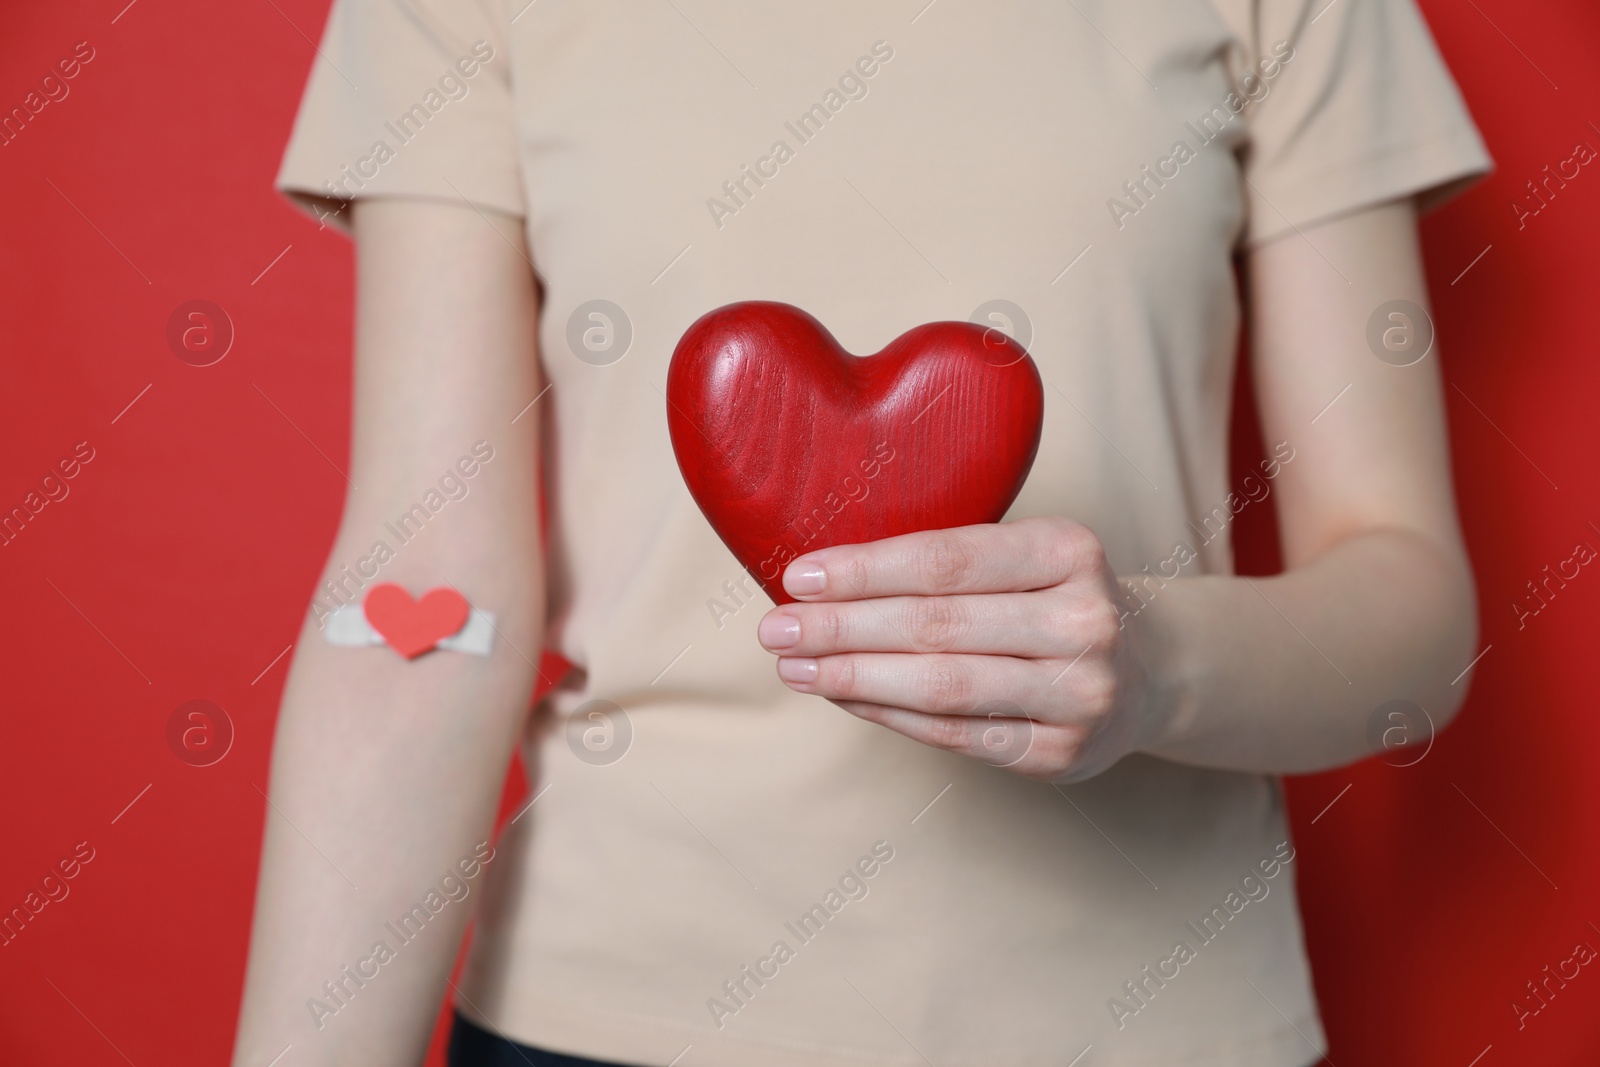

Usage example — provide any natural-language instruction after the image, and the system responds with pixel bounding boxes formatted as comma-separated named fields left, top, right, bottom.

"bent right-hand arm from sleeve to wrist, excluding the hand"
left=1150, top=202, right=1477, bottom=773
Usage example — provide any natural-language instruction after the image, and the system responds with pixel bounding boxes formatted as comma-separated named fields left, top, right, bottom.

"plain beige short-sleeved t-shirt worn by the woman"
left=280, top=0, right=1488, bottom=1067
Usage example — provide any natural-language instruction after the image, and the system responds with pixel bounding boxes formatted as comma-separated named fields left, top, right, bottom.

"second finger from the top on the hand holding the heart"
left=757, top=587, right=1118, bottom=659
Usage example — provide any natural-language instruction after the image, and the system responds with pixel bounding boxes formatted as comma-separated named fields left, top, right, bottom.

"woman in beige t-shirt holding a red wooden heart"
left=235, top=0, right=1488, bottom=1067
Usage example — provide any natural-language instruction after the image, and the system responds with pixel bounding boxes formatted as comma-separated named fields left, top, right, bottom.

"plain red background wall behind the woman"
left=0, top=0, right=1600, bottom=1067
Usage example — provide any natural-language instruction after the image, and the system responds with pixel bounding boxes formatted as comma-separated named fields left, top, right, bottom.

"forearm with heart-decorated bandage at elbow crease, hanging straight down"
left=235, top=521, right=542, bottom=1067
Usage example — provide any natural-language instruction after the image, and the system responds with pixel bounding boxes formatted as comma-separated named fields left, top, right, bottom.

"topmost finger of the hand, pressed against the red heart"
left=784, top=518, right=1104, bottom=601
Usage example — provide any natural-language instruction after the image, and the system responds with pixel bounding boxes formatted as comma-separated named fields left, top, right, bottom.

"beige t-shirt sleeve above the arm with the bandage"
left=277, top=0, right=523, bottom=230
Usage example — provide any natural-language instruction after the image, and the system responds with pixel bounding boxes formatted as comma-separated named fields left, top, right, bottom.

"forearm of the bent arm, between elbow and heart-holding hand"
left=1128, top=530, right=1477, bottom=774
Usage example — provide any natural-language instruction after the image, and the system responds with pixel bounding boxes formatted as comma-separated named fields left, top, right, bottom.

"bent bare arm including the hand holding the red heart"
left=760, top=202, right=1477, bottom=779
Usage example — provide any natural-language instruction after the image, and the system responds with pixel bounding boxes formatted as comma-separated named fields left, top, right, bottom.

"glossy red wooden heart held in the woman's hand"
left=667, top=301, right=1045, bottom=603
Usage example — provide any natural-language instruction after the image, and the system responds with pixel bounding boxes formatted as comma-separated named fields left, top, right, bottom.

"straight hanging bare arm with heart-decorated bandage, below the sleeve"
left=234, top=200, right=544, bottom=1067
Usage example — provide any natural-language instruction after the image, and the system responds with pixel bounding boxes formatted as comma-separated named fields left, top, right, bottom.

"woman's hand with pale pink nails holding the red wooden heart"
left=758, top=518, right=1166, bottom=781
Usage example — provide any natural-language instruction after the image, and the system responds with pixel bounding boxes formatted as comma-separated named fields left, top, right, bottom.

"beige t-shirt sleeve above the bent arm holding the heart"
left=1229, top=0, right=1491, bottom=245
